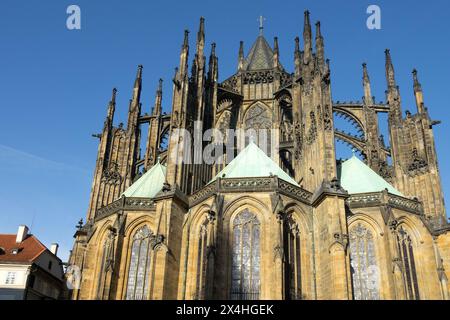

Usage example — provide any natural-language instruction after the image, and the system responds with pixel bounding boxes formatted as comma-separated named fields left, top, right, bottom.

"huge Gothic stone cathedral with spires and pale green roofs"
left=70, top=12, right=450, bottom=300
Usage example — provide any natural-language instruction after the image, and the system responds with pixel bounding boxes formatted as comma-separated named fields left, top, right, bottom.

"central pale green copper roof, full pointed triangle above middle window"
left=211, top=142, right=298, bottom=186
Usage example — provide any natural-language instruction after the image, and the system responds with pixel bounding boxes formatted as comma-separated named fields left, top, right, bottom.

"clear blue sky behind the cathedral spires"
left=0, top=0, right=450, bottom=258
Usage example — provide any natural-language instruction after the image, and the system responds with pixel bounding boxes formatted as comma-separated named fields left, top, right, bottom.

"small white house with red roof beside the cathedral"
left=0, top=226, right=65, bottom=300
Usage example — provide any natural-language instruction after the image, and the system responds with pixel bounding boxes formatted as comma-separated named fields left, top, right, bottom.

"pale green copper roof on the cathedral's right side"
left=338, top=155, right=403, bottom=196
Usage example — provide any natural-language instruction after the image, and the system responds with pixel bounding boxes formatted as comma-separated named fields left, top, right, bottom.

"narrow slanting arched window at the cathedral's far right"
left=397, top=227, right=420, bottom=300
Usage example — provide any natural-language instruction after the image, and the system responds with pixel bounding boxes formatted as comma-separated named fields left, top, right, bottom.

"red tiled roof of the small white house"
left=0, top=234, right=47, bottom=263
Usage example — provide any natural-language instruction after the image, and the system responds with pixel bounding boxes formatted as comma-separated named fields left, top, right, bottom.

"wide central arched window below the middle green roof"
left=230, top=210, right=260, bottom=300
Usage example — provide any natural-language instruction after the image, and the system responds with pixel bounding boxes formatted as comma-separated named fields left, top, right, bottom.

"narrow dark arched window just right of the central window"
left=284, top=219, right=302, bottom=300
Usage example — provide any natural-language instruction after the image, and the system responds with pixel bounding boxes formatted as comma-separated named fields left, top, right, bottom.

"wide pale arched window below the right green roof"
left=350, top=224, right=380, bottom=300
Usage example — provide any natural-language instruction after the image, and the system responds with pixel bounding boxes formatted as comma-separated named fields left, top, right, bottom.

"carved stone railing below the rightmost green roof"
left=347, top=192, right=423, bottom=215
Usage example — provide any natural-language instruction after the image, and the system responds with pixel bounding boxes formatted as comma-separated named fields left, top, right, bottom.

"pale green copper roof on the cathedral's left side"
left=122, top=162, right=167, bottom=198
